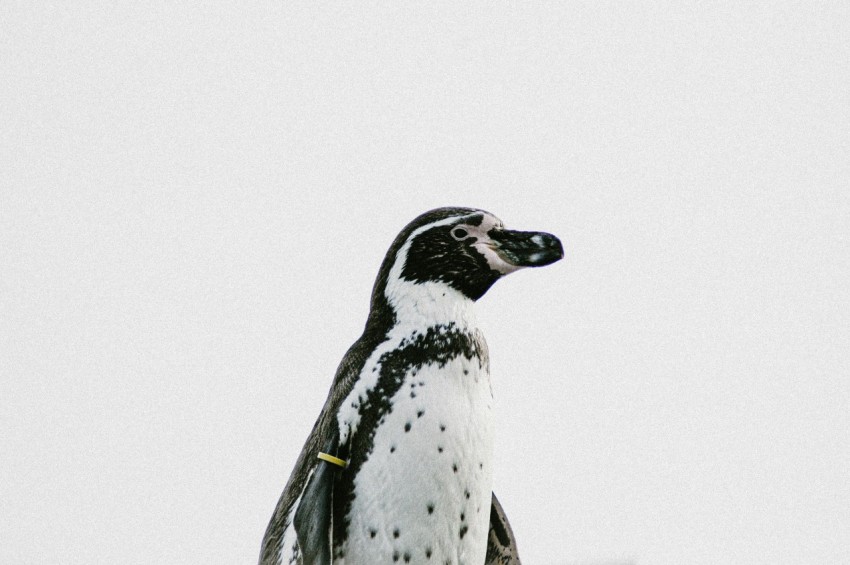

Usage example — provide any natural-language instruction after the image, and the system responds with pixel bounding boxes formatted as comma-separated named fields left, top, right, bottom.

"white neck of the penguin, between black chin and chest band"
left=386, top=280, right=478, bottom=331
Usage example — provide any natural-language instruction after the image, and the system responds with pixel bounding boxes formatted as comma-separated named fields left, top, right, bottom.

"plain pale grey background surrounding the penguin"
left=0, top=1, right=850, bottom=565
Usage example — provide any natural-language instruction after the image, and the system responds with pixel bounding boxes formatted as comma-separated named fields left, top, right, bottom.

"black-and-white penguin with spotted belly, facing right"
left=259, top=208, right=564, bottom=565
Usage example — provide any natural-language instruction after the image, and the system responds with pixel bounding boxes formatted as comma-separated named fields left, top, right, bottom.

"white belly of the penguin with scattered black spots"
left=335, top=356, right=493, bottom=565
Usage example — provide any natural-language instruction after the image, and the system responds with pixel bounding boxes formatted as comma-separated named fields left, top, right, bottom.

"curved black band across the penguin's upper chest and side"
left=334, top=323, right=489, bottom=557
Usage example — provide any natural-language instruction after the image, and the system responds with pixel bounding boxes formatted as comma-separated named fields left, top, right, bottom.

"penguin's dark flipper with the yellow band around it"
left=292, top=433, right=339, bottom=565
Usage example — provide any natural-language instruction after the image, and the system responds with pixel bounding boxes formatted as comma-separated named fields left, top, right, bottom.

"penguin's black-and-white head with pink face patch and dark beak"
left=373, top=208, right=564, bottom=322
